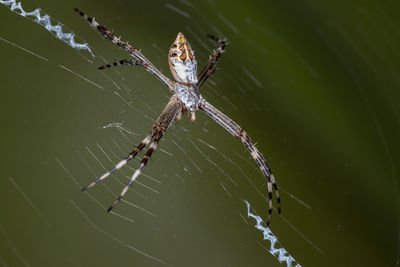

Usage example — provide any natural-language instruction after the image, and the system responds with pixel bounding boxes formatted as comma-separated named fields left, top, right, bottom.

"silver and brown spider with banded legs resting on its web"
left=75, top=9, right=281, bottom=225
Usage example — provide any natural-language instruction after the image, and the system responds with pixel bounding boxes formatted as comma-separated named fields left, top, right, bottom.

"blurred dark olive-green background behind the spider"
left=0, top=0, right=400, bottom=266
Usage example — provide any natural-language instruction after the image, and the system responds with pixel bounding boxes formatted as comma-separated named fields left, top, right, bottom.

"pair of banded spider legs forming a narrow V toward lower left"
left=82, top=96, right=182, bottom=214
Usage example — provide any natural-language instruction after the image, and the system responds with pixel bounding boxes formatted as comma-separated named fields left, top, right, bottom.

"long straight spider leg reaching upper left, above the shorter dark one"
left=75, top=8, right=173, bottom=91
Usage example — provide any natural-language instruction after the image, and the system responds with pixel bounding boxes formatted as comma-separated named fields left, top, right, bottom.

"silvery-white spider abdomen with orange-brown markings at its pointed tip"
left=168, top=32, right=197, bottom=84
